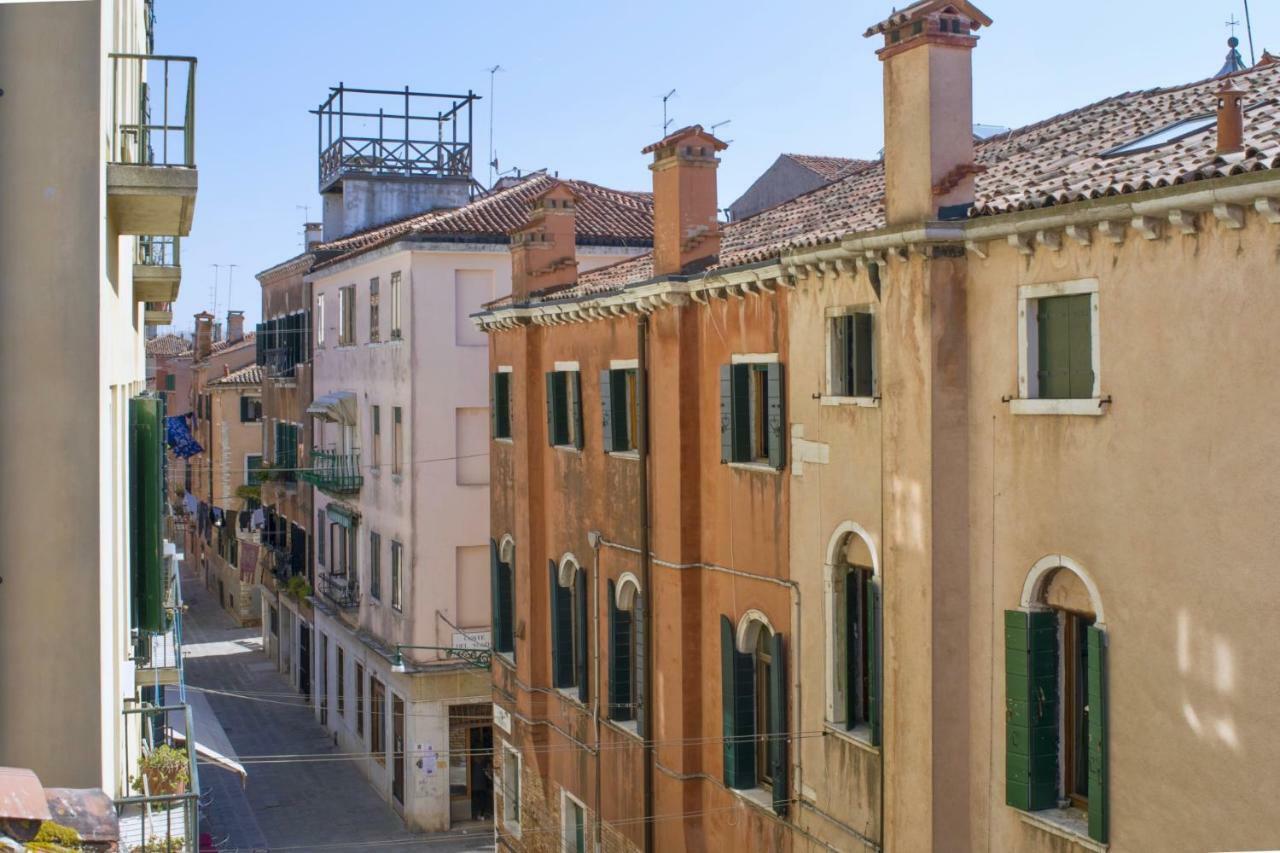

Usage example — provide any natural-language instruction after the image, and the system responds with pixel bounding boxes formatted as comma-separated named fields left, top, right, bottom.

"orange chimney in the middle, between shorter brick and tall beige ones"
left=641, top=124, right=728, bottom=275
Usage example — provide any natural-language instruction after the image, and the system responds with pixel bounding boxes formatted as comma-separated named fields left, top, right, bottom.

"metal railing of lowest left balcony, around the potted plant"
left=115, top=703, right=200, bottom=853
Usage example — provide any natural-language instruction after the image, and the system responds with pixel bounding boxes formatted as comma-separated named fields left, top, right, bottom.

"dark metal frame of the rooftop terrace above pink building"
left=311, top=82, right=480, bottom=192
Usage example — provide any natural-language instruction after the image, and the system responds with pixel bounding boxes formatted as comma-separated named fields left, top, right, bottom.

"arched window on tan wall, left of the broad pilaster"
left=826, top=521, right=881, bottom=745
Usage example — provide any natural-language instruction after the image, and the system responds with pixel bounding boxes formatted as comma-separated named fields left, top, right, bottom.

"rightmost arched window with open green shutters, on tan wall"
left=1005, top=555, right=1108, bottom=843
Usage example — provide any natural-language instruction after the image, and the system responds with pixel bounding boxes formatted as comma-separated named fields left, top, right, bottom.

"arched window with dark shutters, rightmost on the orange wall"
left=721, top=610, right=790, bottom=815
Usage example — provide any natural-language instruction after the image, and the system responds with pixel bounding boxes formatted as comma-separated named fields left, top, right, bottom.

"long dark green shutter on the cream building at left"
left=129, top=396, right=165, bottom=631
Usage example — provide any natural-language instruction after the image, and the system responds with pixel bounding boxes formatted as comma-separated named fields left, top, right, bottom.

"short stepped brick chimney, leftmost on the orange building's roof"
left=511, top=181, right=581, bottom=302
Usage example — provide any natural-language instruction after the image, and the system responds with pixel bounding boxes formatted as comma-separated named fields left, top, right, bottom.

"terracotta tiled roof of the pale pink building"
left=309, top=173, right=653, bottom=268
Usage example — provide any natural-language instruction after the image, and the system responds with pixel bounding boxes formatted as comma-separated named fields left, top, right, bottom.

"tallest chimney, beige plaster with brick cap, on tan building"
left=864, top=0, right=991, bottom=225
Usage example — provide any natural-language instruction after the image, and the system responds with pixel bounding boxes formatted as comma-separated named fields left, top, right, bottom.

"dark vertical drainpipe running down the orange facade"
left=636, top=314, right=657, bottom=853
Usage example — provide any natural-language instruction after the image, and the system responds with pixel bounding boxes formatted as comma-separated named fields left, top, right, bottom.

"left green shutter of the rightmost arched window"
left=1005, top=610, right=1059, bottom=811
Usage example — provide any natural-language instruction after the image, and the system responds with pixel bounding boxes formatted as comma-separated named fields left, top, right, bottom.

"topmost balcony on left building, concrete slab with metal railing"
left=106, top=54, right=197, bottom=234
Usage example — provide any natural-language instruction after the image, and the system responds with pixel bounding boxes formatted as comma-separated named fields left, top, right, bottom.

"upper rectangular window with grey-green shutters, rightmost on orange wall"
left=721, top=361, right=786, bottom=469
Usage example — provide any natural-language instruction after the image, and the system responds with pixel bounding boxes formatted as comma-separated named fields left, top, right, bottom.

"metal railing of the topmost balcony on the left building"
left=110, top=54, right=196, bottom=169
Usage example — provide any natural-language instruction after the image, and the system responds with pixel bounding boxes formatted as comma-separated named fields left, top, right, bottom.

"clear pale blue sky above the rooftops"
left=156, top=0, right=1280, bottom=329
